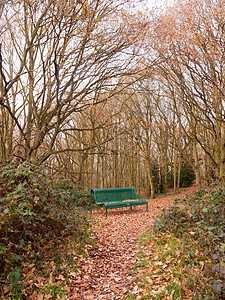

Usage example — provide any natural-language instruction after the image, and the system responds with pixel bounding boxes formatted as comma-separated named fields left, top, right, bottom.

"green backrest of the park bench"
left=91, top=187, right=137, bottom=204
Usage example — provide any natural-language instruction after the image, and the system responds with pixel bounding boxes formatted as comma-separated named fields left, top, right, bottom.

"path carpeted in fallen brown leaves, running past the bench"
left=70, top=186, right=196, bottom=300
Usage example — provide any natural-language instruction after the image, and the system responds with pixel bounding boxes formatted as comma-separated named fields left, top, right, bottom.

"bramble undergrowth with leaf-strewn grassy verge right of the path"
left=124, top=182, right=225, bottom=300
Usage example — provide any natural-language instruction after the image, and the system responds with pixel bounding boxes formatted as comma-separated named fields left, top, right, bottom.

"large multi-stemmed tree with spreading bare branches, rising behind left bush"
left=0, top=0, right=149, bottom=161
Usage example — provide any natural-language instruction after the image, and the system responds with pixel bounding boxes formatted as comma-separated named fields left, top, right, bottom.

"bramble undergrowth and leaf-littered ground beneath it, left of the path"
left=0, top=162, right=91, bottom=299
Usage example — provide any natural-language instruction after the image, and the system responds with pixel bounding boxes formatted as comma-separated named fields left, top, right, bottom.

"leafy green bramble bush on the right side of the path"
left=153, top=182, right=225, bottom=299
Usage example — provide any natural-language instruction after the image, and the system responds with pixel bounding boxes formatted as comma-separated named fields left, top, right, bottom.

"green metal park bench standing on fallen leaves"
left=90, top=187, right=148, bottom=217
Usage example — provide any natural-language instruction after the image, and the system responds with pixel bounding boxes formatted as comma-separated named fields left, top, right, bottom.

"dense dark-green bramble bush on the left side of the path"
left=0, top=162, right=89, bottom=288
